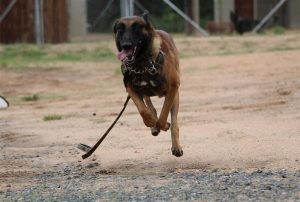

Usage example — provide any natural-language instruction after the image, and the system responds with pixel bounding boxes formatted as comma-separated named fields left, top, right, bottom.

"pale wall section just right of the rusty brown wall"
left=68, top=0, right=87, bottom=37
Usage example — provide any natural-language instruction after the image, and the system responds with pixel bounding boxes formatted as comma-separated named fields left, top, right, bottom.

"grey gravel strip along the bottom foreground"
left=0, top=166, right=300, bottom=201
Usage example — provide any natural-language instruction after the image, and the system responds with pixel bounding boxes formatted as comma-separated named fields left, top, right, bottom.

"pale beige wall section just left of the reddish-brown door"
left=214, top=0, right=234, bottom=22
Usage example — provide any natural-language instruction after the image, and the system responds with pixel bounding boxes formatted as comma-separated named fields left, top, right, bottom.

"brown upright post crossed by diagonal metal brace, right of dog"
left=185, top=0, right=200, bottom=35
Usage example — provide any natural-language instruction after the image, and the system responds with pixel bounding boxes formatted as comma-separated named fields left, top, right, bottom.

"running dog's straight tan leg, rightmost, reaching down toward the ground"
left=171, top=91, right=183, bottom=157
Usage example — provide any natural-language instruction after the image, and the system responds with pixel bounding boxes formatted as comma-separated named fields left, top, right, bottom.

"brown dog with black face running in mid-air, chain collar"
left=113, top=12, right=183, bottom=157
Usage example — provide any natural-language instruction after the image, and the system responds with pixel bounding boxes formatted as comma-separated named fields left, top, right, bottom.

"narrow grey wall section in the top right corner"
left=287, top=0, right=300, bottom=28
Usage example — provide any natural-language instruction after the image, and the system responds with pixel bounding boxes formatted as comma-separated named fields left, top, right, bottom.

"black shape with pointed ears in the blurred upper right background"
left=230, top=11, right=259, bottom=35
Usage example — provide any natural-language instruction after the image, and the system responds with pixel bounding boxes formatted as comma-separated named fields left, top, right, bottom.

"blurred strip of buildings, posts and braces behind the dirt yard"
left=0, top=0, right=300, bottom=44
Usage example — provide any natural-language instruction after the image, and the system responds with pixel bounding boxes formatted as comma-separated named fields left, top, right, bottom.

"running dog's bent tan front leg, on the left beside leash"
left=126, top=87, right=157, bottom=127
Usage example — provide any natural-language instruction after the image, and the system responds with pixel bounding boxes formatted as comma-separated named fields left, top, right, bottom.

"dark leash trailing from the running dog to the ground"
left=78, top=96, right=130, bottom=159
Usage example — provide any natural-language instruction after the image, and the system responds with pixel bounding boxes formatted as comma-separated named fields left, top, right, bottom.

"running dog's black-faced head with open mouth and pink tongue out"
left=113, top=11, right=154, bottom=61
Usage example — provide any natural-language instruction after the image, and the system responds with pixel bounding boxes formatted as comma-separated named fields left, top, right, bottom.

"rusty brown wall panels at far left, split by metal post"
left=0, top=0, right=68, bottom=43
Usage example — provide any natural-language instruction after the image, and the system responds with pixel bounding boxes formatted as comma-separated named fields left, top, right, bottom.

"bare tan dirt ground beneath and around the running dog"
left=0, top=33, right=300, bottom=200
